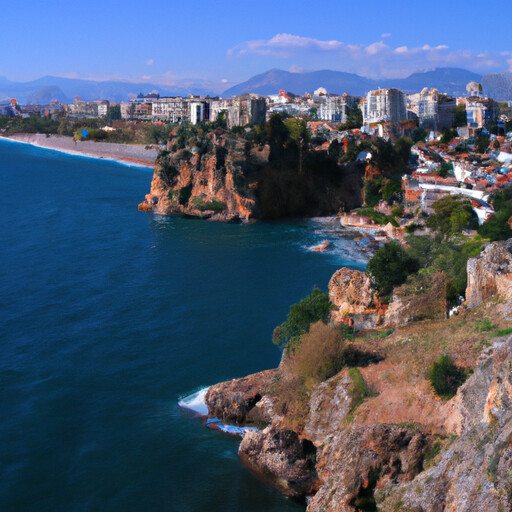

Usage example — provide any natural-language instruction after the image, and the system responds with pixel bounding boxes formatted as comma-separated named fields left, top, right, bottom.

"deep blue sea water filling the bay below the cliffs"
left=0, top=141, right=362, bottom=512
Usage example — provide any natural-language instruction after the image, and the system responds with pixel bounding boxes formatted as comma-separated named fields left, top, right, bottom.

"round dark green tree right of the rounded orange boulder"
left=366, top=240, right=419, bottom=299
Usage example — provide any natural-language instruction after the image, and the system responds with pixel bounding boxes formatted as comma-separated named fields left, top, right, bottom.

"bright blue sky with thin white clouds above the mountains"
left=0, top=0, right=512, bottom=87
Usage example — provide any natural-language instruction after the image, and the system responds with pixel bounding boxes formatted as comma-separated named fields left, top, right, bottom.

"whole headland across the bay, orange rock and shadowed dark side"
left=139, top=128, right=361, bottom=222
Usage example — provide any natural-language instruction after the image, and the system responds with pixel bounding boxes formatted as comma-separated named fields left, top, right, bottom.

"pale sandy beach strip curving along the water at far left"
left=0, top=133, right=158, bottom=169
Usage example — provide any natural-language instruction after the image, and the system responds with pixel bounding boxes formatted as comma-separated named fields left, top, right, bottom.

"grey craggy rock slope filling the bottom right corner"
left=377, top=337, right=512, bottom=512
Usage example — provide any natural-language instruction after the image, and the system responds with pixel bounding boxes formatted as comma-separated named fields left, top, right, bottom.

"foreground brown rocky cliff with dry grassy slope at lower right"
left=202, top=241, right=512, bottom=512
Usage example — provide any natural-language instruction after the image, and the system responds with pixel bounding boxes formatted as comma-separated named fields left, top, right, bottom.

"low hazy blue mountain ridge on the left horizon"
left=0, top=76, right=219, bottom=105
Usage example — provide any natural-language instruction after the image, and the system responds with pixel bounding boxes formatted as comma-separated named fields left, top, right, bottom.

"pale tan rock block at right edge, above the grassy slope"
left=466, top=238, right=512, bottom=308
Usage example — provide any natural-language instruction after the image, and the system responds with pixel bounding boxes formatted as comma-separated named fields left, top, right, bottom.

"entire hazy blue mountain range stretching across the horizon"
left=0, top=68, right=512, bottom=104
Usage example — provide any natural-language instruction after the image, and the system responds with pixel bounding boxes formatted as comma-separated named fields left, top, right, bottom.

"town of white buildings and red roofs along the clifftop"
left=0, top=82, right=512, bottom=224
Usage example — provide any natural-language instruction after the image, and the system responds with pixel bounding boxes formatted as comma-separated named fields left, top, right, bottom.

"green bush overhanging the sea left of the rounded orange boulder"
left=272, top=288, right=331, bottom=352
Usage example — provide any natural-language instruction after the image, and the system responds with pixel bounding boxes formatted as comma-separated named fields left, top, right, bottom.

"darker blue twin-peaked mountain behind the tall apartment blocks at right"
left=222, top=68, right=482, bottom=97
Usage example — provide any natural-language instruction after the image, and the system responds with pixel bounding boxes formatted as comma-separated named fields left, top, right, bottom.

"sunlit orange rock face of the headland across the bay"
left=139, top=132, right=262, bottom=221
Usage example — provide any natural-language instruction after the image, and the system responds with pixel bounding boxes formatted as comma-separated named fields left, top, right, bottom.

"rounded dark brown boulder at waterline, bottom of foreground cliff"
left=238, top=425, right=318, bottom=498
